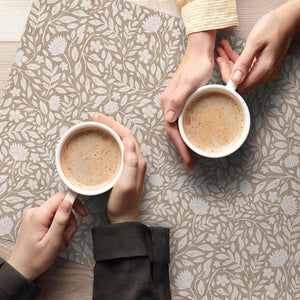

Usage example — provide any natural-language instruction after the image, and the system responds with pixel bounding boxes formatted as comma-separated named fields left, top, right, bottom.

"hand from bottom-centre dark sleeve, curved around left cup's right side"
left=93, top=114, right=147, bottom=223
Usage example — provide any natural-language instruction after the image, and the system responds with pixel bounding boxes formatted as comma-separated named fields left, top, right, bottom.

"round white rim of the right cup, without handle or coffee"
left=178, top=84, right=251, bottom=158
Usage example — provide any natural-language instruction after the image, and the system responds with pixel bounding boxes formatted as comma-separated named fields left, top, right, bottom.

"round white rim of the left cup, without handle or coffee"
left=55, top=121, right=124, bottom=196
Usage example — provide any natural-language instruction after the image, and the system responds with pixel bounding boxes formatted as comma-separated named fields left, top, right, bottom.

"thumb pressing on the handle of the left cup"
left=46, top=200, right=72, bottom=246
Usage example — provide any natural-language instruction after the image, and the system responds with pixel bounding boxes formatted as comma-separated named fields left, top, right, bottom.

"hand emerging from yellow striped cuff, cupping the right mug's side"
left=160, top=30, right=216, bottom=171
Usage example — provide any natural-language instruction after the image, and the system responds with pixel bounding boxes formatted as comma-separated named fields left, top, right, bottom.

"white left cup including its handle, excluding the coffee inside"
left=55, top=122, right=124, bottom=203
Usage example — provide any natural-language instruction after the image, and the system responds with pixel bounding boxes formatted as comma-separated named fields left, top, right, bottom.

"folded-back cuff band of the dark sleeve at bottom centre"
left=92, top=222, right=169, bottom=263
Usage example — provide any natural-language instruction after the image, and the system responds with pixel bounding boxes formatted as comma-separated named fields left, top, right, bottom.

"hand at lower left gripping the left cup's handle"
left=8, top=192, right=87, bottom=280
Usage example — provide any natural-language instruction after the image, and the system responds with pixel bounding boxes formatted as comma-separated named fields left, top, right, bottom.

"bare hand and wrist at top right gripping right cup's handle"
left=216, top=0, right=300, bottom=93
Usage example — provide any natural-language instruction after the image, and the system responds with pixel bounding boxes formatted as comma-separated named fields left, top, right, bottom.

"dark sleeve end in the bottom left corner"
left=0, top=257, right=40, bottom=300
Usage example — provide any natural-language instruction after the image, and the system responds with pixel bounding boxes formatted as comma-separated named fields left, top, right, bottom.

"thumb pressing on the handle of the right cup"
left=231, top=42, right=259, bottom=84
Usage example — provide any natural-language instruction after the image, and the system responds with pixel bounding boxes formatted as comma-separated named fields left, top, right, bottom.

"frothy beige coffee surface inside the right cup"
left=183, top=91, right=245, bottom=153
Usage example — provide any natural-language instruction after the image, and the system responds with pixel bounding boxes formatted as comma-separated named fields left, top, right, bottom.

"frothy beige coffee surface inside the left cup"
left=60, top=128, right=121, bottom=190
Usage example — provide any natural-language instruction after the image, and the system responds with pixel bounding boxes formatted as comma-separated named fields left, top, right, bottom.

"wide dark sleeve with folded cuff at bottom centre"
left=92, top=222, right=171, bottom=300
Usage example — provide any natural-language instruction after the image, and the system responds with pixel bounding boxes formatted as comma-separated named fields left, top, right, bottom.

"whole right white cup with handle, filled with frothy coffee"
left=178, top=80, right=250, bottom=158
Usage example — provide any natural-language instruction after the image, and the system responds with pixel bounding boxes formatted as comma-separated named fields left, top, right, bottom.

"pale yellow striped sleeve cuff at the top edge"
left=181, top=0, right=239, bottom=35
